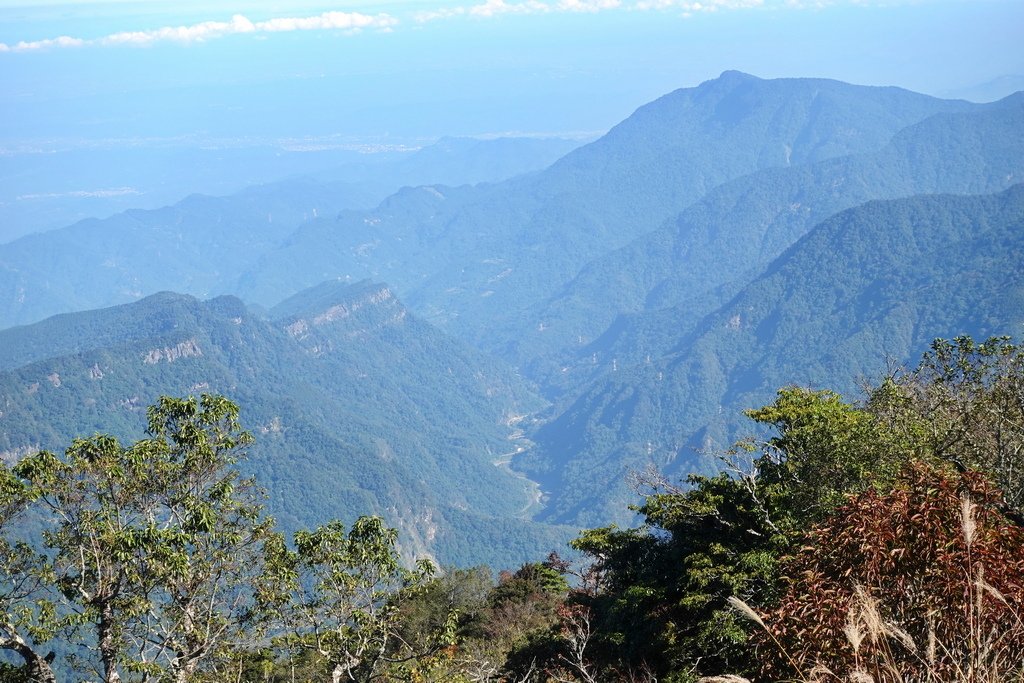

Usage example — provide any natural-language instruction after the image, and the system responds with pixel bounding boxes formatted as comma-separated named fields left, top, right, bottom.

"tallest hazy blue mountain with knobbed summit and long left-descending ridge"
left=238, top=72, right=975, bottom=353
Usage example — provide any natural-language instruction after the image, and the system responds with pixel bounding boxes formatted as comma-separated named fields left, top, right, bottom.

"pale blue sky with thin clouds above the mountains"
left=0, top=0, right=1024, bottom=145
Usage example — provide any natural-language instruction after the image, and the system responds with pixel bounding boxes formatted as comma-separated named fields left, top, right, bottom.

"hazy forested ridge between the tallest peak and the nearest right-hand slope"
left=520, top=93, right=1024, bottom=390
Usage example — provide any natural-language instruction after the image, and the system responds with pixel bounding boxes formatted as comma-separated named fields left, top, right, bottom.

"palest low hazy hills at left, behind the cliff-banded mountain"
left=0, top=138, right=578, bottom=327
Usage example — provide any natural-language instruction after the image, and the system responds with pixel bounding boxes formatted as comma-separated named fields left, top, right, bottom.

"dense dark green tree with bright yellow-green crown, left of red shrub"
left=572, top=388, right=905, bottom=676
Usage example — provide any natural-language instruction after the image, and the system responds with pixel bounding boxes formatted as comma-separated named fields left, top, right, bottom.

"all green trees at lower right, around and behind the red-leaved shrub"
left=572, top=338, right=1024, bottom=677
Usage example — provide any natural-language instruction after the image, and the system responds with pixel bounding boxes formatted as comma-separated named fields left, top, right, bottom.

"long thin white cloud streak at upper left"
left=0, top=11, right=398, bottom=52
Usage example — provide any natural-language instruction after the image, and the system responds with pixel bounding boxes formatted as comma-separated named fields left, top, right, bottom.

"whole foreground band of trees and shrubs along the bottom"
left=0, top=337, right=1024, bottom=683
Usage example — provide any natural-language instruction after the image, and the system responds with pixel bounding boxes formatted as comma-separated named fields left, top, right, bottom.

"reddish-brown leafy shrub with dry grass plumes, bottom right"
left=755, top=465, right=1024, bottom=683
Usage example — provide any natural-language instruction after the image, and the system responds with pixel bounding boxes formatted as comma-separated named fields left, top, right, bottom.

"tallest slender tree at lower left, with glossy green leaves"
left=131, top=395, right=283, bottom=683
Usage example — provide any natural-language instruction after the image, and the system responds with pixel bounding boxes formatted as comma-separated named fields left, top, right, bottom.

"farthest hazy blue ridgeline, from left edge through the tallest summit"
left=0, top=72, right=977, bottom=350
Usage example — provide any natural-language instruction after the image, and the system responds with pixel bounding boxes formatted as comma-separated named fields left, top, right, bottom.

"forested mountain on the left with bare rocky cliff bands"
left=0, top=282, right=572, bottom=566
